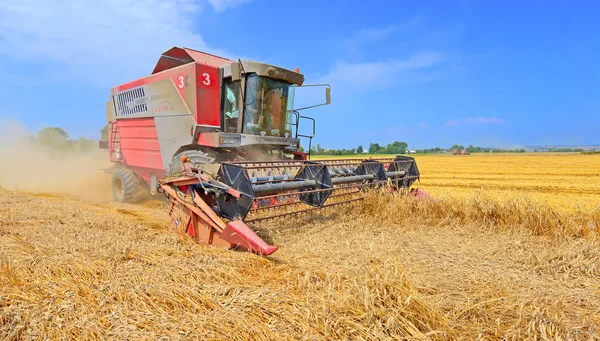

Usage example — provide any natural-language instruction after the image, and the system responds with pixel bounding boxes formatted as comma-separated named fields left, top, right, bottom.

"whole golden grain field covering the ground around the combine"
left=0, top=154, right=600, bottom=340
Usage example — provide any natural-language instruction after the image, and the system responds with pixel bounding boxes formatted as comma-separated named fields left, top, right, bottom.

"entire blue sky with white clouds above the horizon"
left=0, top=0, right=600, bottom=148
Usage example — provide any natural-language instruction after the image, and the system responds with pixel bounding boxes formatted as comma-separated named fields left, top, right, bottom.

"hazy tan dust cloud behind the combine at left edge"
left=0, top=117, right=112, bottom=201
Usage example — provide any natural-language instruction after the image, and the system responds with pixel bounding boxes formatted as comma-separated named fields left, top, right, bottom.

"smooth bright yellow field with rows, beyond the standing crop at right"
left=416, top=153, right=600, bottom=212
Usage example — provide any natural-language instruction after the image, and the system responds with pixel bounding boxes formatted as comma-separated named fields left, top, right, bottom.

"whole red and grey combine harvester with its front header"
left=101, top=47, right=419, bottom=255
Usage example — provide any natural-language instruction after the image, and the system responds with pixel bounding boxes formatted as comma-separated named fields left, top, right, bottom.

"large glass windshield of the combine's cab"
left=243, top=74, right=294, bottom=137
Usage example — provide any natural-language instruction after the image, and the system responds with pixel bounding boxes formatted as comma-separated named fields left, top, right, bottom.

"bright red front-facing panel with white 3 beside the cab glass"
left=196, top=64, right=221, bottom=127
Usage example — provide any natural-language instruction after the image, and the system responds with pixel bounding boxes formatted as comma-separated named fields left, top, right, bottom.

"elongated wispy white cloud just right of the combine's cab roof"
left=322, top=52, right=444, bottom=88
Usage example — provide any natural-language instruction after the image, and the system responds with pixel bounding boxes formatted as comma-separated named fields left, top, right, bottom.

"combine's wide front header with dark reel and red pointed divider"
left=160, top=156, right=420, bottom=255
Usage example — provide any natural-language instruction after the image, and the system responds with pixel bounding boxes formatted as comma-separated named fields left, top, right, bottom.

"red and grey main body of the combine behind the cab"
left=111, top=48, right=230, bottom=181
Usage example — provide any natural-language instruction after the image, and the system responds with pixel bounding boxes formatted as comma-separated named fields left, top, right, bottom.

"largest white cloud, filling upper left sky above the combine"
left=0, top=0, right=248, bottom=86
